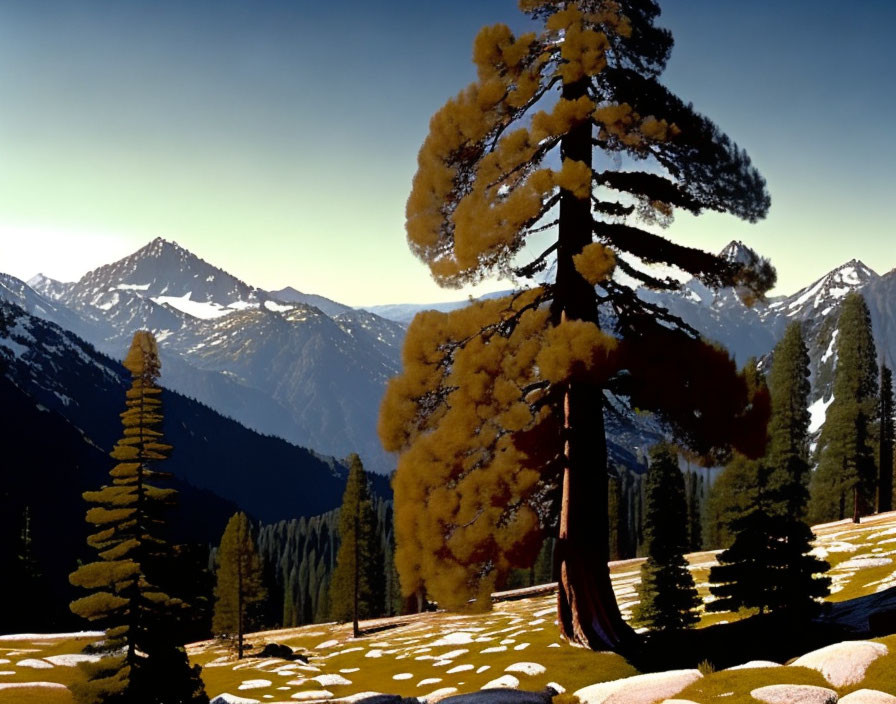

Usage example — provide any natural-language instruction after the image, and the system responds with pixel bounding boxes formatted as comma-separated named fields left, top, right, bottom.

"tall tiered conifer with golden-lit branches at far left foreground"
left=70, top=330, right=208, bottom=704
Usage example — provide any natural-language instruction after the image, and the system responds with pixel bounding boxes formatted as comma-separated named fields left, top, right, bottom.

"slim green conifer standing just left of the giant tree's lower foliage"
left=330, top=453, right=385, bottom=638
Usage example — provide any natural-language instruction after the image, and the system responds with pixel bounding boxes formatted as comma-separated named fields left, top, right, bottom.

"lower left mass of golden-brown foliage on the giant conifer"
left=380, top=290, right=557, bottom=608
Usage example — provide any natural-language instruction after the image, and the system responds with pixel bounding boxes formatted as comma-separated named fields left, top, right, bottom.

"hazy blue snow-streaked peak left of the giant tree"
left=25, top=238, right=403, bottom=473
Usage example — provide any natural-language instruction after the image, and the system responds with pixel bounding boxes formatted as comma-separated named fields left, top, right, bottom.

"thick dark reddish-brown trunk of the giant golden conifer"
left=551, top=81, right=633, bottom=650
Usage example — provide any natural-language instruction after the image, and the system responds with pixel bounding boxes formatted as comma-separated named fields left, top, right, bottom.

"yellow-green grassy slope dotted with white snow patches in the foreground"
left=0, top=513, right=896, bottom=704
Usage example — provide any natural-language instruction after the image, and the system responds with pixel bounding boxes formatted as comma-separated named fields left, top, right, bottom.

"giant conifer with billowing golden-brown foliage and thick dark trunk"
left=380, top=0, right=774, bottom=649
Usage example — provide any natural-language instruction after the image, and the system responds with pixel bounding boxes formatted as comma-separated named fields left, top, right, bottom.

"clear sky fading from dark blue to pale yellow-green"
left=0, top=0, right=896, bottom=305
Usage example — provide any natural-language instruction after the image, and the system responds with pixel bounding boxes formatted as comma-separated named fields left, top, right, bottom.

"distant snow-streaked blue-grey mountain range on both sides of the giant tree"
left=0, top=238, right=896, bottom=484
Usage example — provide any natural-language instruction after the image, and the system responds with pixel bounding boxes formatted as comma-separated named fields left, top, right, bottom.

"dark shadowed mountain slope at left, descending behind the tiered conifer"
left=0, top=300, right=387, bottom=524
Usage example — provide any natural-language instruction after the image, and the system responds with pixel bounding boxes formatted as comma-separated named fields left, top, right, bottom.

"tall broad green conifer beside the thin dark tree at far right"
left=809, top=292, right=879, bottom=523
